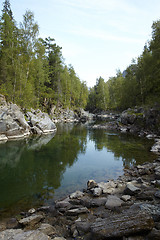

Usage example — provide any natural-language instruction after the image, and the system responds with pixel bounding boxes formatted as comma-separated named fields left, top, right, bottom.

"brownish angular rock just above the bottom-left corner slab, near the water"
left=19, top=215, right=44, bottom=227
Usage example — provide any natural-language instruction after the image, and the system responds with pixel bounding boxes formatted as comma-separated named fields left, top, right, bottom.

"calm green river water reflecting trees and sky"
left=0, top=124, right=156, bottom=217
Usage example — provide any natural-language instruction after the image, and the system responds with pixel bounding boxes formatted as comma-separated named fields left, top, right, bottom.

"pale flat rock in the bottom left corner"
left=0, top=229, right=51, bottom=240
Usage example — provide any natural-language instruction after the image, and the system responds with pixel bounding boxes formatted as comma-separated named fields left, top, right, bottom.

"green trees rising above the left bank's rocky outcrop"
left=0, top=0, right=88, bottom=111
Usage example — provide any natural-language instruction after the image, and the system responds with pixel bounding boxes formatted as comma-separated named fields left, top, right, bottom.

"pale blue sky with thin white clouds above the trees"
left=0, top=0, right=160, bottom=87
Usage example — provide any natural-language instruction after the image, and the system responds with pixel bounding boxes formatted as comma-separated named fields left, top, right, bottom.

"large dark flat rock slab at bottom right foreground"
left=90, top=211, right=154, bottom=240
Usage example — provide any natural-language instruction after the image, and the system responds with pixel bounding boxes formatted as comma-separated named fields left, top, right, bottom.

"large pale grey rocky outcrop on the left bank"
left=0, top=95, right=56, bottom=141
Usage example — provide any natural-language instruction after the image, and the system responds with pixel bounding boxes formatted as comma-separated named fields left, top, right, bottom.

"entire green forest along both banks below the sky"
left=0, top=0, right=160, bottom=112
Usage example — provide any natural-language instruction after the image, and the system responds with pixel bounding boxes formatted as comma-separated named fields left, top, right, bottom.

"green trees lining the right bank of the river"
left=87, top=20, right=160, bottom=111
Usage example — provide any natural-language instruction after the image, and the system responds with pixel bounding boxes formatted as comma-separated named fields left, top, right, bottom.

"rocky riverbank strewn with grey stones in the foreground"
left=0, top=157, right=160, bottom=240
